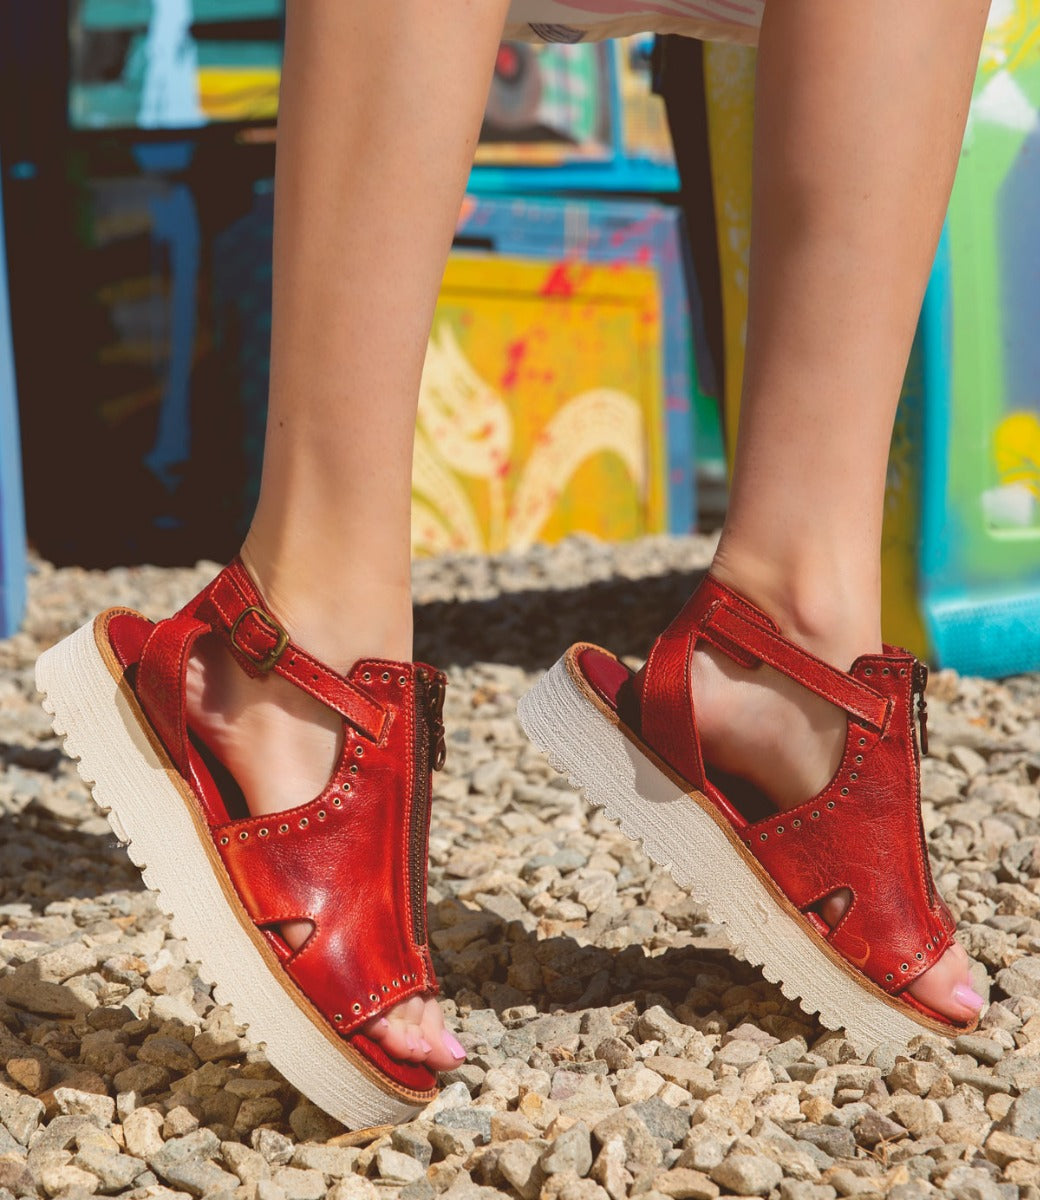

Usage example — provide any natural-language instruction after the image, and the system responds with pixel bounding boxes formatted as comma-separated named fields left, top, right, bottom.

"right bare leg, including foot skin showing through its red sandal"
left=696, top=0, right=988, bottom=1019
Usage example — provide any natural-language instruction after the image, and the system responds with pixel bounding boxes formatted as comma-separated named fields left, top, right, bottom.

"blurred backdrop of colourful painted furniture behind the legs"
left=0, top=0, right=1040, bottom=674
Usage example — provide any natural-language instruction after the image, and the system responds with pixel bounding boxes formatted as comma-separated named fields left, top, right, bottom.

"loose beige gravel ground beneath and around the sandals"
left=0, top=538, right=1040, bottom=1200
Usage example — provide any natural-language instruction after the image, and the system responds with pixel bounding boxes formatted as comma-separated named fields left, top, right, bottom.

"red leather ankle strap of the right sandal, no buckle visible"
left=701, top=592, right=891, bottom=733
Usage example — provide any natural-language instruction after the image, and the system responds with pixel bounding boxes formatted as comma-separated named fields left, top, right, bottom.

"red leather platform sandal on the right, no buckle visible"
left=519, top=576, right=978, bottom=1052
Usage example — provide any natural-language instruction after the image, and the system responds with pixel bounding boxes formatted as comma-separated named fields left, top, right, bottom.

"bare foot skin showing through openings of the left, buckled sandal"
left=187, top=635, right=465, bottom=1070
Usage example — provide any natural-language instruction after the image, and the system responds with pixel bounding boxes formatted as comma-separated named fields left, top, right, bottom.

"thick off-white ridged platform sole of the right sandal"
left=517, top=656, right=931, bottom=1054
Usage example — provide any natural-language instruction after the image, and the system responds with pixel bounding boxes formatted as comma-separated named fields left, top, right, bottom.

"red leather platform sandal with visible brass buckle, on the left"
left=36, top=560, right=446, bottom=1128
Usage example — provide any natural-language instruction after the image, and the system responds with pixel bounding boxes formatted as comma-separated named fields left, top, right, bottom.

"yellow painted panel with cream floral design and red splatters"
left=411, top=256, right=667, bottom=554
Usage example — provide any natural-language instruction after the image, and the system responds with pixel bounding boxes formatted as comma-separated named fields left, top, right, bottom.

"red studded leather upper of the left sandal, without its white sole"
left=107, top=562, right=446, bottom=1090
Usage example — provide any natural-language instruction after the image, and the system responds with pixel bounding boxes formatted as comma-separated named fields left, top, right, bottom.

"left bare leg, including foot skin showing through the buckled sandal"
left=190, top=0, right=506, bottom=1069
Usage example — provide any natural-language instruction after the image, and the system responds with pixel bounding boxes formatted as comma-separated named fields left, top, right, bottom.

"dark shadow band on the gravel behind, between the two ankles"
left=415, top=569, right=705, bottom=671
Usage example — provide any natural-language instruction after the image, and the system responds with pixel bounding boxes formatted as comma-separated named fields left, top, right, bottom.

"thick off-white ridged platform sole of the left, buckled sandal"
left=36, top=623, right=425, bottom=1129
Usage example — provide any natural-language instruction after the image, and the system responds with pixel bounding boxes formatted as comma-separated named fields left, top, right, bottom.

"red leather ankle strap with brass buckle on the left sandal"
left=198, top=558, right=387, bottom=742
